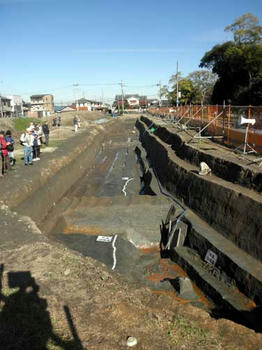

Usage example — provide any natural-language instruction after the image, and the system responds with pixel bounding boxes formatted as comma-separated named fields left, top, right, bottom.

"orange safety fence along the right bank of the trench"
left=148, top=105, right=262, bottom=153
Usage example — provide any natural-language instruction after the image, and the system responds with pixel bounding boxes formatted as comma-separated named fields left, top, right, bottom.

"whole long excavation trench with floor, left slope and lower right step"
left=2, top=119, right=262, bottom=330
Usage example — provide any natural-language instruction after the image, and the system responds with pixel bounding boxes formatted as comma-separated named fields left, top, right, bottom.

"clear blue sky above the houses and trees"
left=0, top=0, right=262, bottom=103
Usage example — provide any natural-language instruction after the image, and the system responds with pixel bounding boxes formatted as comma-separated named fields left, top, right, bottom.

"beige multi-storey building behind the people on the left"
left=30, top=94, right=54, bottom=118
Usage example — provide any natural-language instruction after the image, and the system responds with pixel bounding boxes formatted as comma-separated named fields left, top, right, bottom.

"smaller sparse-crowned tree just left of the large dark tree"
left=187, top=70, right=218, bottom=105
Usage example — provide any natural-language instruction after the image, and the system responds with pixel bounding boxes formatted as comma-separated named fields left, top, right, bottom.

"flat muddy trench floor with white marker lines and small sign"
left=45, top=119, right=212, bottom=310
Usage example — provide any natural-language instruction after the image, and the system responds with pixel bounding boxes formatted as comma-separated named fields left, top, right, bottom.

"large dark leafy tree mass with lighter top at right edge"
left=200, top=14, right=262, bottom=105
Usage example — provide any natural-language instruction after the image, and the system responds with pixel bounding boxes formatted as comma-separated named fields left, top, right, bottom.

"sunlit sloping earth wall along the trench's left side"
left=0, top=121, right=114, bottom=224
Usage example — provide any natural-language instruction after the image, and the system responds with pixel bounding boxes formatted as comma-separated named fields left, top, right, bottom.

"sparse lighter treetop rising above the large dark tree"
left=225, top=13, right=262, bottom=44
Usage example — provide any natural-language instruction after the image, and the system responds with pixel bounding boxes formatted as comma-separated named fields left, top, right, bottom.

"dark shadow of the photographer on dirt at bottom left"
left=0, top=264, right=84, bottom=350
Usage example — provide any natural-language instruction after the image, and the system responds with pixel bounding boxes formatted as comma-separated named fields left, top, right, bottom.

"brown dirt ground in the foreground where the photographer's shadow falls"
left=0, top=113, right=262, bottom=350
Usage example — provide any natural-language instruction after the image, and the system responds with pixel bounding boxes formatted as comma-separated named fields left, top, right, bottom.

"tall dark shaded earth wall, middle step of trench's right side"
left=137, top=121, right=262, bottom=260
